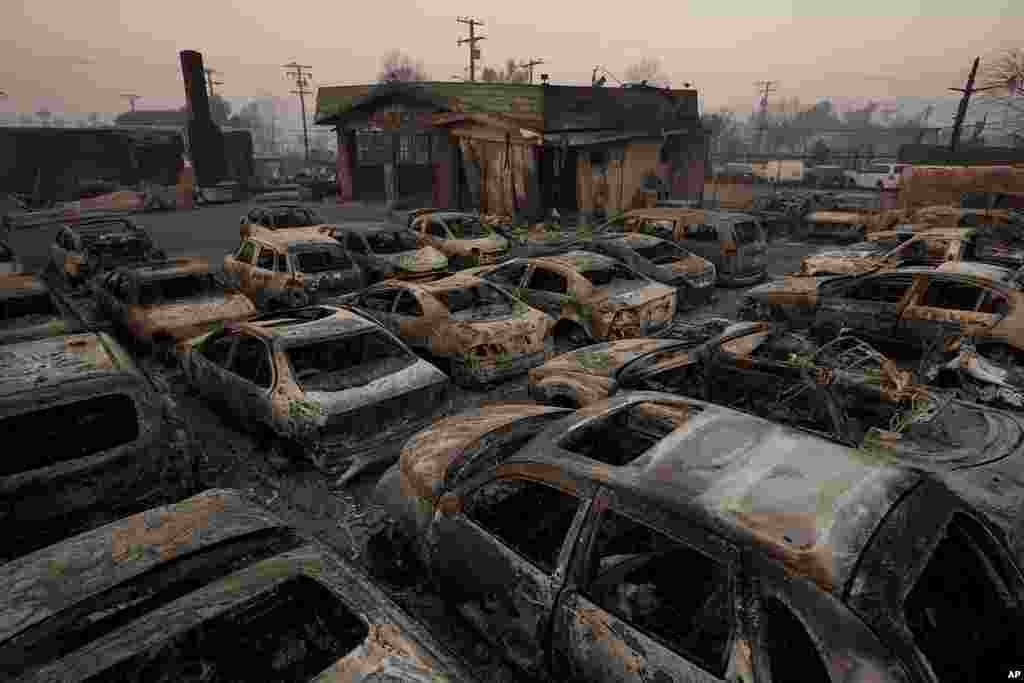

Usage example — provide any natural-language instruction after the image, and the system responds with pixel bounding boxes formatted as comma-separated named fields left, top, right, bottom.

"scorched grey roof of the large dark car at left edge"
left=0, top=333, right=138, bottom=397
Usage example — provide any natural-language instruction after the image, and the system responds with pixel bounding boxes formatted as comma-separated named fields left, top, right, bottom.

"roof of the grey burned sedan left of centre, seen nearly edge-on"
left=233, top=304, right=379, bottom=346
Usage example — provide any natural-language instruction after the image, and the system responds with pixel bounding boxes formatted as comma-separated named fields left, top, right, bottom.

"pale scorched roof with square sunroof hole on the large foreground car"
left=505, top=391, right=922, bottom=595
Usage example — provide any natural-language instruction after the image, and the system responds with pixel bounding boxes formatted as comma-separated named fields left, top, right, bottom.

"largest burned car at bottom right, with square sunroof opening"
left=373, top=392, right=1024, bottom=683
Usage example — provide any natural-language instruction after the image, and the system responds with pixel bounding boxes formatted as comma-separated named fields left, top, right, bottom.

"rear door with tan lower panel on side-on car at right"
left=897, top=274, right=1010, bottom=348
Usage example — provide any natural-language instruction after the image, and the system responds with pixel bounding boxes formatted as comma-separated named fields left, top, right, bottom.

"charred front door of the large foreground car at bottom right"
left=428, top=473, right=589, bottom=675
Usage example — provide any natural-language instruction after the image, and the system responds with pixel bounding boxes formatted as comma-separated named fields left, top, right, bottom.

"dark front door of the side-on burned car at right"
left=814, top=273, right=913, bottom=341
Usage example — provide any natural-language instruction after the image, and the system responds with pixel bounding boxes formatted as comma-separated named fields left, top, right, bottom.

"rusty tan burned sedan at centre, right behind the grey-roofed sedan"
left=354, top=273, right=555, bottom=386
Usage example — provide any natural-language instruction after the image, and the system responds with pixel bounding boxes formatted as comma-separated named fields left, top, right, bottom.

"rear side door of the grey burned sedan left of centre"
left=224, top=335, right=274, bottom=430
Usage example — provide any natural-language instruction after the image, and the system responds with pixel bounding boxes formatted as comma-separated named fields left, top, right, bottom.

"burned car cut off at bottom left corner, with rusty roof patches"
left=0, top=489, right=471, bottom=683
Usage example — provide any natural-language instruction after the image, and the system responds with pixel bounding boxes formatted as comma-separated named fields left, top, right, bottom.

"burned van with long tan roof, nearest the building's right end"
left=595, top=208, right=768, bottom=287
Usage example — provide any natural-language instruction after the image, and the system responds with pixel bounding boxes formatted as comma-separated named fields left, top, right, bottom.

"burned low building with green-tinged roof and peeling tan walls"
left=316, top=82, right=705, bottom=222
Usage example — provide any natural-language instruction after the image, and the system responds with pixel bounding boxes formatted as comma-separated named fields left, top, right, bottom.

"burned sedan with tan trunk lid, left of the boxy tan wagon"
left=93, top=256, right=256, bottom=359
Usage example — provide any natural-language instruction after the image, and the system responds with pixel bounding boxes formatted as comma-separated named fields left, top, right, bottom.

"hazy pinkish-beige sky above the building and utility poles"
left=0, top=0, right=1024, bottom=112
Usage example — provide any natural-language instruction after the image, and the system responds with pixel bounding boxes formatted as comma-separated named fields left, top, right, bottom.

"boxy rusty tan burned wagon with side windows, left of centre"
left=224, top=220, right=364, bottom=309
